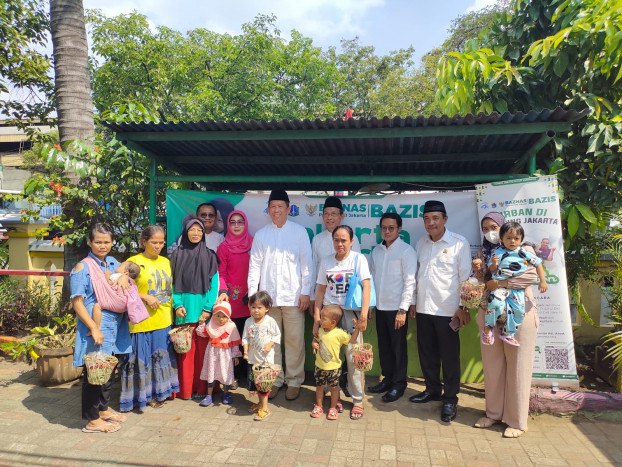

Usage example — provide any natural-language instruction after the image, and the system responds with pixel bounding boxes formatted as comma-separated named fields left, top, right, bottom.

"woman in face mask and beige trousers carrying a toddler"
left=472, top=212, right=538, bottom=438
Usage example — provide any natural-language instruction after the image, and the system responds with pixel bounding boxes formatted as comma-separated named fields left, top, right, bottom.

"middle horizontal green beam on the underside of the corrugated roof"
left=166, top=152, right=523, bottom=166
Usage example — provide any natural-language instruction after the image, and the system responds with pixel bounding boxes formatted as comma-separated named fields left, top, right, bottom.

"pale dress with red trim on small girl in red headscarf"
left=197, top=318, right=242, bottom=385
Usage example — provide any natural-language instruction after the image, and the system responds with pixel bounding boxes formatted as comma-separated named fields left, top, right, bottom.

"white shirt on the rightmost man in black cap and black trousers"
left=413, top=230, right=471, bottom=316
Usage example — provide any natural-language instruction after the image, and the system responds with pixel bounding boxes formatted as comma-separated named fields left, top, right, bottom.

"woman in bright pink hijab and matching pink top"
left=217, top=211, right=253, bottom=384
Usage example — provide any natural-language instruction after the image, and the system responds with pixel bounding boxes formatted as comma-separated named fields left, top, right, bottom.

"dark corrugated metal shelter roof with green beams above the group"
left=105, top=108, right=586, bottom=191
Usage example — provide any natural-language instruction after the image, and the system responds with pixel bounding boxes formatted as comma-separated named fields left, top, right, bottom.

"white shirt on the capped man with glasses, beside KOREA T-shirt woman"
left=371, top=237, right=417, bottom=311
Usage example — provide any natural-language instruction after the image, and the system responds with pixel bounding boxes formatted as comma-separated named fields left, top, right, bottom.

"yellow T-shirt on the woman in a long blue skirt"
left=128, top=253, right=173, bottom=333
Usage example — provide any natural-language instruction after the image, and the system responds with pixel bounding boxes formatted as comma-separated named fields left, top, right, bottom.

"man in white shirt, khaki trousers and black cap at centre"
left=248, top=190, right=314, bottom=400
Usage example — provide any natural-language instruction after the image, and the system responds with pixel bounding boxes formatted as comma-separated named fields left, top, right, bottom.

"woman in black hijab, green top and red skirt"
left=171, top=215, right=219, bottom=399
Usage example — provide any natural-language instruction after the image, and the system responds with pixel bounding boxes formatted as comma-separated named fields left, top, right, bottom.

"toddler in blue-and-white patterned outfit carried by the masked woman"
left=481, top=222, right=548, bottom=347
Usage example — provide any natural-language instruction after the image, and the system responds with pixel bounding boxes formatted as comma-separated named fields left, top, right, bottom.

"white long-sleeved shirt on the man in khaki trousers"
left=248, top=220, right=313, bottom=306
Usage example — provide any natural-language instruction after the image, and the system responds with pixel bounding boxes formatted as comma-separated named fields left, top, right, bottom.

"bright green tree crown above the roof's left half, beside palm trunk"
left=89, top=11, right=336, bottom=121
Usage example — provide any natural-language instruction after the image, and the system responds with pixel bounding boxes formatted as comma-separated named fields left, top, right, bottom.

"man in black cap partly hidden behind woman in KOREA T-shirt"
left=309, top=196, right=361, bottom=316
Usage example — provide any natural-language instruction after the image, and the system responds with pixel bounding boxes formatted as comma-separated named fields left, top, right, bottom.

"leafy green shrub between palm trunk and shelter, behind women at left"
left=9, top=103, right=169, bottom=254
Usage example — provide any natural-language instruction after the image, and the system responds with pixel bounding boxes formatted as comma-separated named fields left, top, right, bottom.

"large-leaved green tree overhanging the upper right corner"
left=437, top=0, right=622, bottom=285
